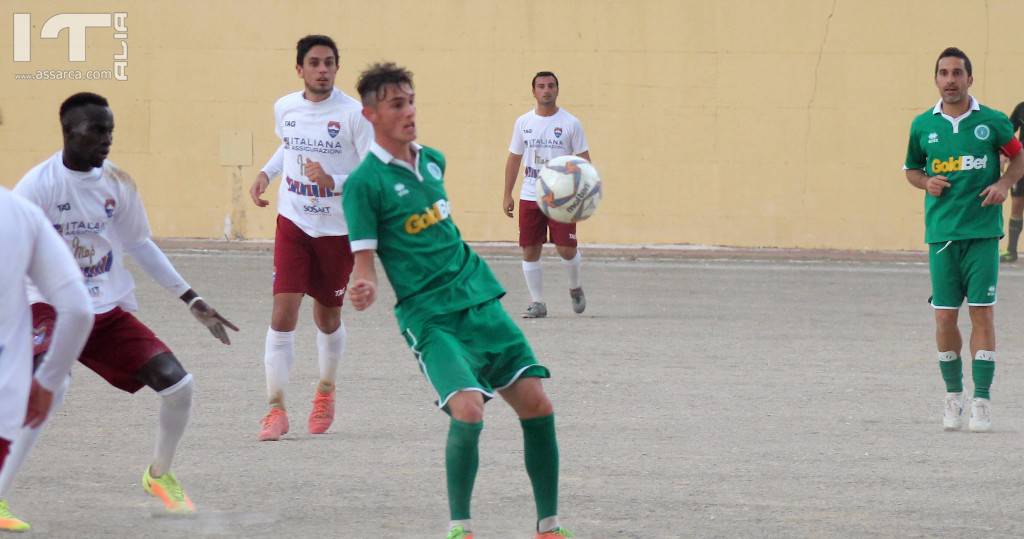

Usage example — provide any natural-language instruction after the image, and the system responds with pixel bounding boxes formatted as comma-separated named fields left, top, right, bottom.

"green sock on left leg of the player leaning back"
left=444, top=419, right=483, bottom=521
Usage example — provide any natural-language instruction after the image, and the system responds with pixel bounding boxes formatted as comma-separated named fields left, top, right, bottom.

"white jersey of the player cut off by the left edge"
left=0, top=188, right=82, bottom=441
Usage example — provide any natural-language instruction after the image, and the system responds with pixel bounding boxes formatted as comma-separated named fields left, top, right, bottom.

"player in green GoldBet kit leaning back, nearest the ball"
left=342, top=64, right=569, bottom=539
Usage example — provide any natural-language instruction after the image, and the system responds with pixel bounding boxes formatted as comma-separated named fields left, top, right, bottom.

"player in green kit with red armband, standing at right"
left=903, top=47, right=1024, bottom=432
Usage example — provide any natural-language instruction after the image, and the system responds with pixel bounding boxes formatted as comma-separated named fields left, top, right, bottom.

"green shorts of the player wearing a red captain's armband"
left=928, top=238, right=999, bottom=308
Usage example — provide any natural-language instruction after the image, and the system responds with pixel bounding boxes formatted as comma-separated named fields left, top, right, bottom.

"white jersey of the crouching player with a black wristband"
left=14, top=152, right=151, bottom=314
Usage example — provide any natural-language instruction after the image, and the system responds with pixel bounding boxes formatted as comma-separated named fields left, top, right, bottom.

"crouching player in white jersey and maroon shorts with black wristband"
left=0, top=92, right=238, bottom=528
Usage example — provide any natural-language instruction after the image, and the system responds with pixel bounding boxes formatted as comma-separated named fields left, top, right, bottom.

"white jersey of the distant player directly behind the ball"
left=509, top=109, right=590, bottom=200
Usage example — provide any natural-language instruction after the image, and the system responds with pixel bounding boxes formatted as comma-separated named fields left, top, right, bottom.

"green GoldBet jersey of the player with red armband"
left=903, top=97, right=1014, bottom=243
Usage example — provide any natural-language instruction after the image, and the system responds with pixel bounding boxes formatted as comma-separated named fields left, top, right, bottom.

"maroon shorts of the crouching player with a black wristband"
left=32, top=303, right=171, bottom=393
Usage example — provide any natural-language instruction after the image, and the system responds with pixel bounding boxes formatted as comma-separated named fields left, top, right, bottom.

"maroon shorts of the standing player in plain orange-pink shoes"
left=273, top=215, right=354, bottom=307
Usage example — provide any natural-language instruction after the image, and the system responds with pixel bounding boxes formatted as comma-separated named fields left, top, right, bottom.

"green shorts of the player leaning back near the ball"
left=402, top=299, right=551, bottom=410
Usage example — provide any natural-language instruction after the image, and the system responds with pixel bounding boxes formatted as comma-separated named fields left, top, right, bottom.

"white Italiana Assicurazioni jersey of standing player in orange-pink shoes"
left=264, top=88, right=374, bottom=238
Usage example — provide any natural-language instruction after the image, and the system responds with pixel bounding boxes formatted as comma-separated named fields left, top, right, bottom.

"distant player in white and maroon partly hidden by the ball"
left=502, top=71, right=590, bottom=318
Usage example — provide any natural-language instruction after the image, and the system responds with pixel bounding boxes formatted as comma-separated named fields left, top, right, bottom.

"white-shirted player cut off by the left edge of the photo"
left=0, top=188, right=92, bottom=532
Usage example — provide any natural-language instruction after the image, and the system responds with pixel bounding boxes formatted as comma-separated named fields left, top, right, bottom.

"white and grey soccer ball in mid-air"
left=536, top=156, right=601, bottom=223
